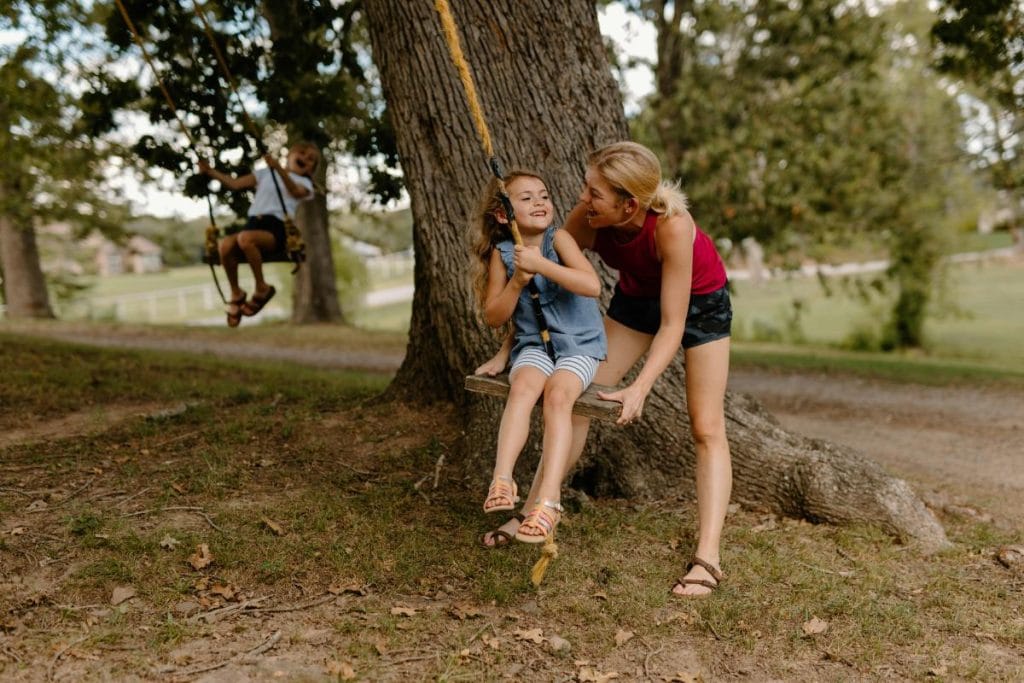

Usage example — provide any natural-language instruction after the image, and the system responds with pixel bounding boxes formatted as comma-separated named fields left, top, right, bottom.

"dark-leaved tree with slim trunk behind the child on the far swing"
left=98, top=0, right=400, bottom=323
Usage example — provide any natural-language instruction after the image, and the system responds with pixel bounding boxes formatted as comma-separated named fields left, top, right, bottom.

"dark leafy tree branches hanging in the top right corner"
left=932, top=0, right=1024, bottom=245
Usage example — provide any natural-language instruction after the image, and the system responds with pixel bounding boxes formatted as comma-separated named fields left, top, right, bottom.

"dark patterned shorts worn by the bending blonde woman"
left=607, top=285, right=732, bottom=348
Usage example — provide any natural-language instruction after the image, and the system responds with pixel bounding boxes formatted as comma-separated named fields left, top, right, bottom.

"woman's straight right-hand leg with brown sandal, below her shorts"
left=672, top=338, right=732, bottom=595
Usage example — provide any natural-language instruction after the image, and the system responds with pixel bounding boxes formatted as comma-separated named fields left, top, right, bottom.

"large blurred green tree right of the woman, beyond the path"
left=628, top=0, right=961, bottom=348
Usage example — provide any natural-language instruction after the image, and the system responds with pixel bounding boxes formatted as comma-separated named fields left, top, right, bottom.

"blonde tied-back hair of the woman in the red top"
left=587, top=141, right=687, bottom=216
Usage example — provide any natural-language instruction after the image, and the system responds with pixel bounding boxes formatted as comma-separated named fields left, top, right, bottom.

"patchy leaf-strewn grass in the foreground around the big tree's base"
left=0, top=326, right=1024, bottom=681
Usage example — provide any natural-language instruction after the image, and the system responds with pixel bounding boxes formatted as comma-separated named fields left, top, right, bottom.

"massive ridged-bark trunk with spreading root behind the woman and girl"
left=366, top=0, right=945, bottom=547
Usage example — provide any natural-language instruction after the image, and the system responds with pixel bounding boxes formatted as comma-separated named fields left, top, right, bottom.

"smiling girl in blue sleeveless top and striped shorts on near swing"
left=473, top=171, right=607, bottom=547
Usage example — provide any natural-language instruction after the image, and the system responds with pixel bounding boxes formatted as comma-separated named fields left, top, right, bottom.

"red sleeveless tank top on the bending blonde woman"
left=594, top=206, right=726, bottom=297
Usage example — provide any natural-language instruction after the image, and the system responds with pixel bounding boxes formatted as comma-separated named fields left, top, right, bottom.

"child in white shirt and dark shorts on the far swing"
left=199, top=142, right=319, bottom=328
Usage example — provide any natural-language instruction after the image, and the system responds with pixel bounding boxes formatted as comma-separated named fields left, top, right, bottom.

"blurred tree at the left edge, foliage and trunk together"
left=0, top=1, right=128, bottom=317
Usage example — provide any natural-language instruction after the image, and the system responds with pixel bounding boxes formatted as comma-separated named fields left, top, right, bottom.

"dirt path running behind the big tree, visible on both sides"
left=8, top=328, right=1024, bottom=525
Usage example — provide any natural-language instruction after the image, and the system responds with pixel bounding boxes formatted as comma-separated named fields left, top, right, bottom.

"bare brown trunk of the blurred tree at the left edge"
left=0, top=216, right=53, bottom=318
